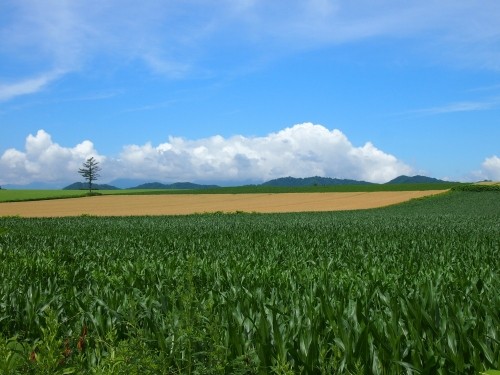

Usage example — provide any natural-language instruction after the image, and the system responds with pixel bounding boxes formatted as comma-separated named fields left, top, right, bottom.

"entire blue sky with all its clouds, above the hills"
left=0, top=0, right=500, bottom=186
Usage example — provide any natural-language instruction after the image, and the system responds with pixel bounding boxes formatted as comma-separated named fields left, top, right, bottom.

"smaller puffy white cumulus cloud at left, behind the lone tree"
left=0, top=130, right=105, bottom=184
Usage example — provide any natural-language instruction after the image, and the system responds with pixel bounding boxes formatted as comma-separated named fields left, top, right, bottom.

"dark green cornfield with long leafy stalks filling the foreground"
left=0, top=191, right=500, bottom=374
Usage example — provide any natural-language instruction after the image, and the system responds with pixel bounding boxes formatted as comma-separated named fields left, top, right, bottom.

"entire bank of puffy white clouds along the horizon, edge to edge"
left=0, top=123, right=500, bottom=184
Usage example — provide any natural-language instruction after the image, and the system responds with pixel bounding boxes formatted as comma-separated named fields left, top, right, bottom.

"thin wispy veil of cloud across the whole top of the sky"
left=0, top=0, right=500, bottom=100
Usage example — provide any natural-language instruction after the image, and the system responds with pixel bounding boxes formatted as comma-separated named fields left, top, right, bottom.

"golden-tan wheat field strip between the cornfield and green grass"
left=0, top=190, right=443, bottom=217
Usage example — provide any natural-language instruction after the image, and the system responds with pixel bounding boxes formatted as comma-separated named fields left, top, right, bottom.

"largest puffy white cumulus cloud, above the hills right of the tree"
left=111, top=123, right=412, bottom=182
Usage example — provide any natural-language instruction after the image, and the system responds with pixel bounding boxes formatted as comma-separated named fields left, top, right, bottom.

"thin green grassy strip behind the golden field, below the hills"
left=0, top=182, right=459, bottom=202
